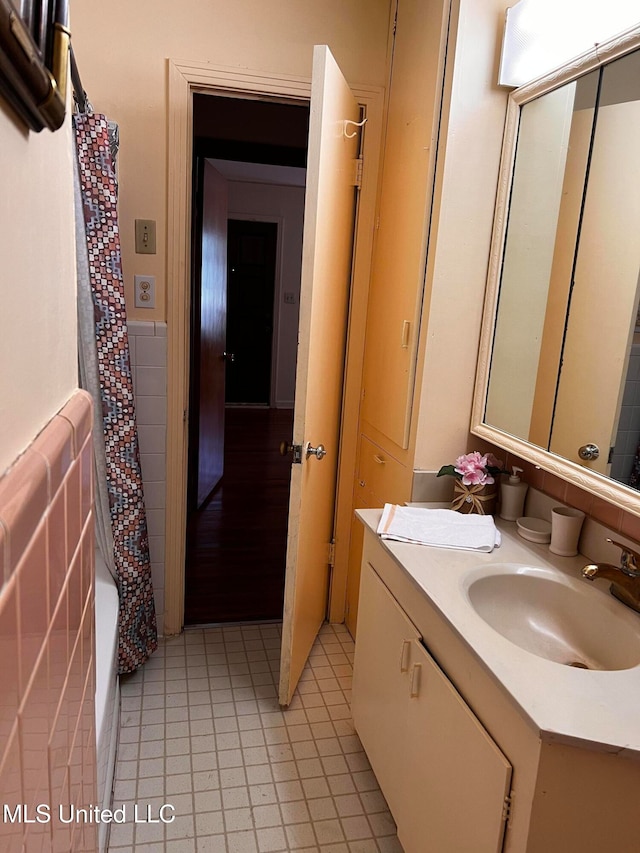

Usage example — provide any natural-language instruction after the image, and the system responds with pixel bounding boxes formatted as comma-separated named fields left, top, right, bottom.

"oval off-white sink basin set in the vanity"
left=465, top=563, right=640, bottom=670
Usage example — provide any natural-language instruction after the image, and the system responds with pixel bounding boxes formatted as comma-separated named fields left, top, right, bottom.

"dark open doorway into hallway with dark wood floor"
left=184, top=94, right=309, bottom=625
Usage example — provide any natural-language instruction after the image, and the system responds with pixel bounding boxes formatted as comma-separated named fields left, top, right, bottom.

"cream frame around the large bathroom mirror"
left=470, top=25, right=640, bottom=516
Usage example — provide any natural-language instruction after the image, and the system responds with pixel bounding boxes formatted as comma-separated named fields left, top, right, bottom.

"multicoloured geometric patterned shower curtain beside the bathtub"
left=73, top=113, right=158, bottom=673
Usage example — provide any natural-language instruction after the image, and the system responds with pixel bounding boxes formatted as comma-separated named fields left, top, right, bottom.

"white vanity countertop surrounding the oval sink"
left=356, top=509, right=640, bottom=760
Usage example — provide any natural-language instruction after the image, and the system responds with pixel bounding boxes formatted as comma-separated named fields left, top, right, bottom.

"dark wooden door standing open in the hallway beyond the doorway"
left=193, top=160, right=228, bottom=507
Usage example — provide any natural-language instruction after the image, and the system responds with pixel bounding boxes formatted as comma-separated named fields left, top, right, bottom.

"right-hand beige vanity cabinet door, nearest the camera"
left=398, top=641, right=511, bottom=853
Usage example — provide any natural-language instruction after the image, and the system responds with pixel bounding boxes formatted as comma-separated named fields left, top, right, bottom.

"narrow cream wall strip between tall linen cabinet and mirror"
left=414, top=0, right=508, bottom=471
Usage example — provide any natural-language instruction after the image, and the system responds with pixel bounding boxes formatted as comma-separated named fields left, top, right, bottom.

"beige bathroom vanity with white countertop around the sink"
left=352, top=510, right=640, bottom=853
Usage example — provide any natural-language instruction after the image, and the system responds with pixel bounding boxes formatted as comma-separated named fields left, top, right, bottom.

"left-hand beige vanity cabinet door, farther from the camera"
left=352, top=563, right=420, bottom=821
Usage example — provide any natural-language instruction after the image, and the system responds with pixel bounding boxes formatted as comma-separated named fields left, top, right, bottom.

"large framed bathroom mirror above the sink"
left=471, top=27, right=640, bottom=515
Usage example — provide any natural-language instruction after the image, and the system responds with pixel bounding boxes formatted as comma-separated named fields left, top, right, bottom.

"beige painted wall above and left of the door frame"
left=71, top=0, right=389, bottom=320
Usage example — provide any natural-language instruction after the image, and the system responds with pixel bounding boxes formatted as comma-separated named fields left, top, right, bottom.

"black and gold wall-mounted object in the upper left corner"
left=0, top=0, right=71, bottom=132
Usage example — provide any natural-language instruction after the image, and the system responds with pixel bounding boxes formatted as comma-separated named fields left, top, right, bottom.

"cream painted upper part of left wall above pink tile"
left=0, top=101, right=78, bottom=474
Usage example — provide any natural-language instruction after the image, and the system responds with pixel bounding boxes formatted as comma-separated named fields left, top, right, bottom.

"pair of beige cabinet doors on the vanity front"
left=352, top=562, right=511, bottom=853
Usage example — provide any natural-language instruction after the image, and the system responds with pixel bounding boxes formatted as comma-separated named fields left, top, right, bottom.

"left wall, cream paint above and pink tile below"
left=0, top=65, right=89, bottom=850
